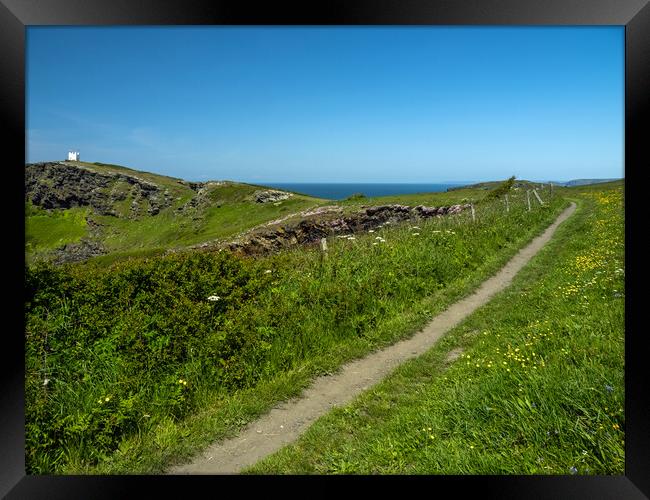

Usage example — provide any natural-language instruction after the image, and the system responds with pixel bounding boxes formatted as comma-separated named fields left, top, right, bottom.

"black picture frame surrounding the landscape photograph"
left=0, top=0, right=650, bottom=499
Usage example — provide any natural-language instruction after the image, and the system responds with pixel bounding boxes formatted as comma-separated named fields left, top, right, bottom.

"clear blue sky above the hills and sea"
left=26, top=26, right=624, bottom=182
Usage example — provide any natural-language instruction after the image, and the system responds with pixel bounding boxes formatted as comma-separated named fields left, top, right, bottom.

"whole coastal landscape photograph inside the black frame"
left=23, top=25, right=626, bottom=477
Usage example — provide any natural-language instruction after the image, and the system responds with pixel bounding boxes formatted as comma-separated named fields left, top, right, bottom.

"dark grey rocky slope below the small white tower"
left=25, top=162, right=172, bottom=217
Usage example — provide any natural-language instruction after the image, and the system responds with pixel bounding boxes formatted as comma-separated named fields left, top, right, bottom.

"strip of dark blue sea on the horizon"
left=264, top=182, right=471, bottom=200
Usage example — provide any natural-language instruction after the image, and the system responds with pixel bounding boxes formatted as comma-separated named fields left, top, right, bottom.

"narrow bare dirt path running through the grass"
left=167, top=203, right=576, bottom=474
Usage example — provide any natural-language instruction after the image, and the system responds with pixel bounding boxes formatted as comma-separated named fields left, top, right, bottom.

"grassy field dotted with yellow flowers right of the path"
left=247, top=182, right=625, bottom=475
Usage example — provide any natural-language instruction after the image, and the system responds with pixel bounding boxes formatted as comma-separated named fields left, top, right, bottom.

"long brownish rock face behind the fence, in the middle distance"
left=216, top=205, right=469, bottom=255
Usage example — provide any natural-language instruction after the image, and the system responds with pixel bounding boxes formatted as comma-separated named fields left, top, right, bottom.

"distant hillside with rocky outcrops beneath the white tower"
left=25, top=161, right=326, bottom=262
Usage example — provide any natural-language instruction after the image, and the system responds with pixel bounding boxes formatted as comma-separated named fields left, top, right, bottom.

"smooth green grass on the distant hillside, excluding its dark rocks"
left=25, top=162, right=326, bottom=266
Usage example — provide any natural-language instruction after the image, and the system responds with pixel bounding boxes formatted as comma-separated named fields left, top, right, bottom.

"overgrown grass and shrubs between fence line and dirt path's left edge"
left=25, top=178, right=567, bottom=474
